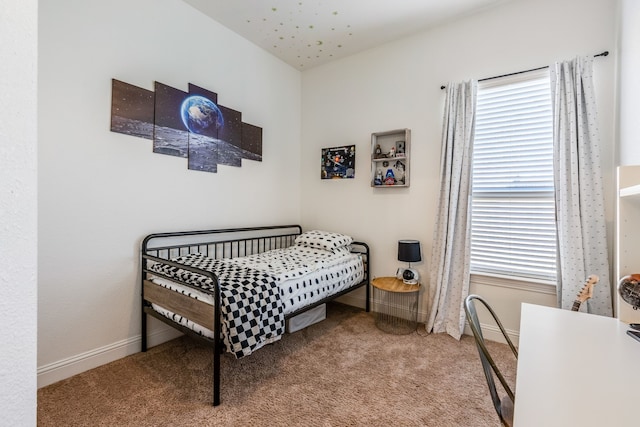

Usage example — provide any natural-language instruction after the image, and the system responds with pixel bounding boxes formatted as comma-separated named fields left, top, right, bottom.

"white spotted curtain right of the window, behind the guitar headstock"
left=550, top=57, right=613, bottom=316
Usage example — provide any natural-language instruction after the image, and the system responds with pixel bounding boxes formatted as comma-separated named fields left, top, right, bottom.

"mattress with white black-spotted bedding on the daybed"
left=151, top=246, right=364, bottom=344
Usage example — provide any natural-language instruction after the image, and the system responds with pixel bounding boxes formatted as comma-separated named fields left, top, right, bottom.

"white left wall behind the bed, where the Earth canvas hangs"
left=38, top=0, right=301, bottom=385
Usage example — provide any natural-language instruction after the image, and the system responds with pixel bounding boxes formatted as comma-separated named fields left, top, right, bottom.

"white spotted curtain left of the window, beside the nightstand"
left=426, top=81, right=477, bottom=339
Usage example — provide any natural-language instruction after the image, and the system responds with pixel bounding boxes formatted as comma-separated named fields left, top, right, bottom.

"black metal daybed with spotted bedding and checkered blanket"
left=140, top=225, right=370, bottom=406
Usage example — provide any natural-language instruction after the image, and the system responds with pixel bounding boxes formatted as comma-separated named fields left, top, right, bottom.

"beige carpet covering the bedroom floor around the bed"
left=38, top=304, right=515, bottom=427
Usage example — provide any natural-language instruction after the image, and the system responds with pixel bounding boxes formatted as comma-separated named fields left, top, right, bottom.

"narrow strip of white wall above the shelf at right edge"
left=619, top=0, right=640, bottom=165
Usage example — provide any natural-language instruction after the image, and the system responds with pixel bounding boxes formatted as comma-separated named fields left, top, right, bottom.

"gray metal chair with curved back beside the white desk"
left=464, top=295, right=518, bottom=427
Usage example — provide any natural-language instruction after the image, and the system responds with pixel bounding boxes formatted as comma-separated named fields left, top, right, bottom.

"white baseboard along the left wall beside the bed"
left=38, top=326, right=182, bottom=388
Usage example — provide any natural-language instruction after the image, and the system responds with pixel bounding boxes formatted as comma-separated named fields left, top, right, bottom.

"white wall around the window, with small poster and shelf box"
left=302, top=0, right=616, bottom=333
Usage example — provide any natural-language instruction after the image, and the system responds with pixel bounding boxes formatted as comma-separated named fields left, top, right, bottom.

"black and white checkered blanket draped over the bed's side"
left=151, top=254, right=285, bottom=358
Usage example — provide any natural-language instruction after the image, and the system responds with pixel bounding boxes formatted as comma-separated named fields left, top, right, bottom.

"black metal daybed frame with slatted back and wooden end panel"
left=140, top=225, right=371, bottom=406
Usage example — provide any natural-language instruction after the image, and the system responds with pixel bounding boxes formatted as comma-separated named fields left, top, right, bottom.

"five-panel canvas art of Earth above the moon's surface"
left=111, top=79, right=262, bottom=173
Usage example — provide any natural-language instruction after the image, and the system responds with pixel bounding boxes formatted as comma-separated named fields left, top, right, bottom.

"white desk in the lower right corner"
left=514, top=304, right=640, bottom=427
